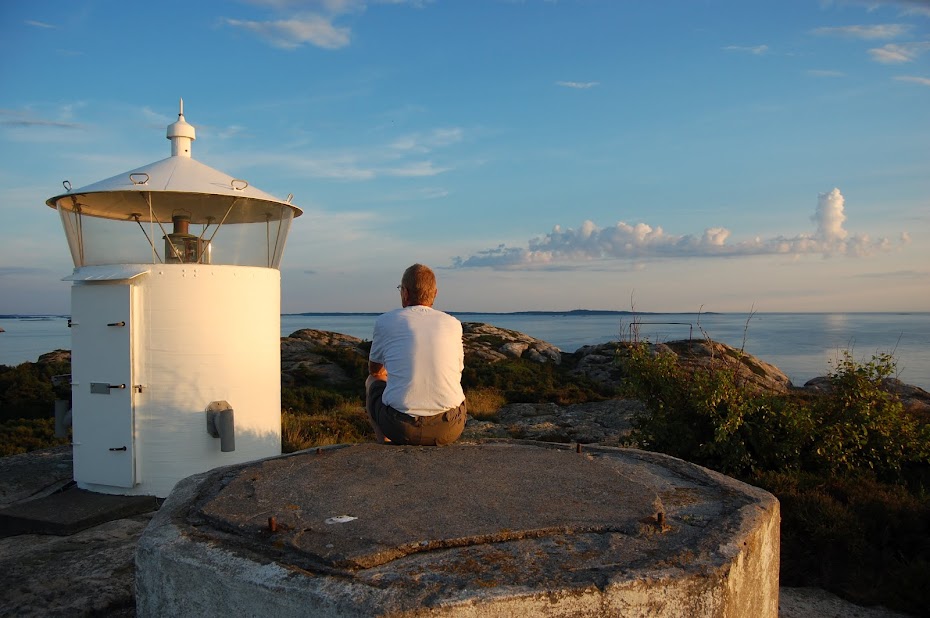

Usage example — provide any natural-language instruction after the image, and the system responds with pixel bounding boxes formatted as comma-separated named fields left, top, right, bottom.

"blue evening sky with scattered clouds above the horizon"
left=0, top=0, right=930, bottom=313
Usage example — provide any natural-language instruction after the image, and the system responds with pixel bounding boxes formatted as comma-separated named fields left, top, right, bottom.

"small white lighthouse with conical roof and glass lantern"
left=46, top=101, right=301, bottom=497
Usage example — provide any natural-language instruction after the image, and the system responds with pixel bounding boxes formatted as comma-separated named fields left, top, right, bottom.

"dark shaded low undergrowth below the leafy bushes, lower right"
left=753, top=472, right=930, bottom=615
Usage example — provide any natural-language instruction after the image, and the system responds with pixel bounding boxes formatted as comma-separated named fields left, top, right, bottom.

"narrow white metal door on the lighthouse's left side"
left=71, top=281, right=135, bottom=487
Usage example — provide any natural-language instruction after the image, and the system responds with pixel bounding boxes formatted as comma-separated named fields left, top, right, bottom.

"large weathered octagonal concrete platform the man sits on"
left=136, top=442, right=779, bottom=618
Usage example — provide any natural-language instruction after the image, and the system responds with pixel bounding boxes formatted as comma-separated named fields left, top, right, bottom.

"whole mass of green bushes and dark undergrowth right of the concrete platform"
left=623, top=343, right=930, bottom=615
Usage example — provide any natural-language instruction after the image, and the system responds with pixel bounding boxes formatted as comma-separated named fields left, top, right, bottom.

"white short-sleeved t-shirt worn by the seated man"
left=368, top=305, right=465, bottom=416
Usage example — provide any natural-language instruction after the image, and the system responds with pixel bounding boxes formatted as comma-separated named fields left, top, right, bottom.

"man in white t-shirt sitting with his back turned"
left=365, top=264, right=465, bottom=446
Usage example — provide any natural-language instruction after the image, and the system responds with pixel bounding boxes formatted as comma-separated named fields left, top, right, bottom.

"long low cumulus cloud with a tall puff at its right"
left=452, top=189, right=907, bottom=268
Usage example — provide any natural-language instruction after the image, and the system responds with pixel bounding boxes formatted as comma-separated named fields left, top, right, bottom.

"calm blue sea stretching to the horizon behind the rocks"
left=0, top=311, right=930, bottom=390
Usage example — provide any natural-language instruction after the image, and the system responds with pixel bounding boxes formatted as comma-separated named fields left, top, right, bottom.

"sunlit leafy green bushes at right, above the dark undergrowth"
left=625, top=343, right=930, bottom=481
